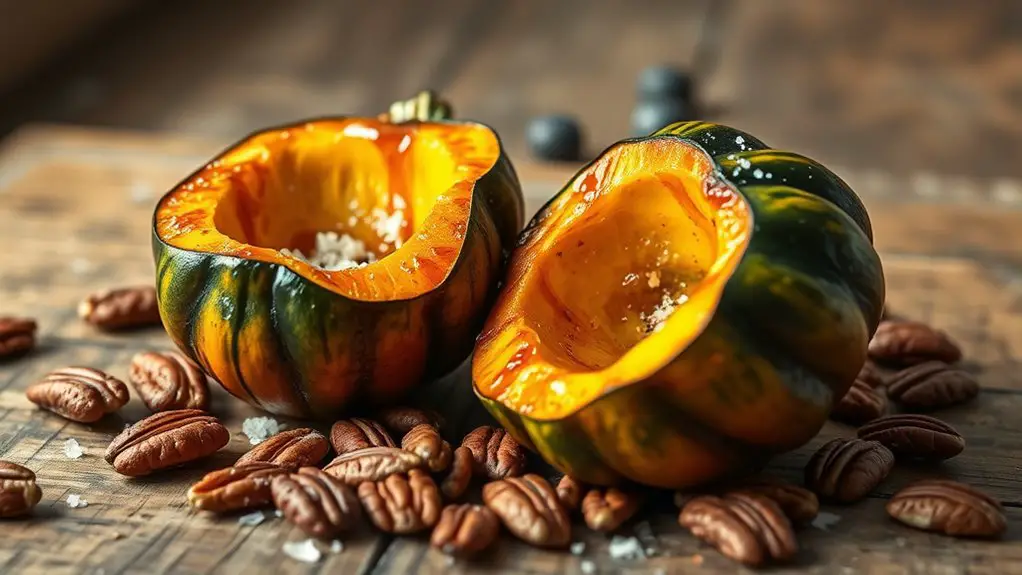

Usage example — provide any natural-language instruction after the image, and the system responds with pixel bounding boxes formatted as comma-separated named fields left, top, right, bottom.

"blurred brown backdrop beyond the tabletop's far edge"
left=0, top=0, right=1022, bottom=177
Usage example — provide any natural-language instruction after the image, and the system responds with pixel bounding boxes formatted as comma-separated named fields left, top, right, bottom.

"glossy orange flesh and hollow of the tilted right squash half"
left=473, top=137, right=751, bottom=420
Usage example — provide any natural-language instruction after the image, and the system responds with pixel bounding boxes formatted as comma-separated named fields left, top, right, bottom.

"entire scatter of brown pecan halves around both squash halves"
left=0, top=296, right=1006, bottom=566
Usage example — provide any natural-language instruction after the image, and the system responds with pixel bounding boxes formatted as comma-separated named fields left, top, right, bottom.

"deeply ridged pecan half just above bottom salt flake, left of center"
left=273, top=467, right=362, bottom=539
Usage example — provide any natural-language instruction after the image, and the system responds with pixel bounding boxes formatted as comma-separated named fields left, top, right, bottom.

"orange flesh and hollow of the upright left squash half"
left=155, top=118, right=501, bottom=301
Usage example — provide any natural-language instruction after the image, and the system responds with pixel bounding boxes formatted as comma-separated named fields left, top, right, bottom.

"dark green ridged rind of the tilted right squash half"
left=473, top=122, right=884, bottom=488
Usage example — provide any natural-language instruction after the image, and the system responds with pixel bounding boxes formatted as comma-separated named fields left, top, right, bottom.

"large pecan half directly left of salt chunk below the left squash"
left=104, top=410, right=231, bottom=477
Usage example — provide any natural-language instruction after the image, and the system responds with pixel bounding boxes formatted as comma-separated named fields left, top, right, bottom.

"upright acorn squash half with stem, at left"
left=152, top=94, right=524, bottom=417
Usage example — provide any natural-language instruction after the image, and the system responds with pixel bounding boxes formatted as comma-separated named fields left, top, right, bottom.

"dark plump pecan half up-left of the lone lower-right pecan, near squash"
left=805, top=437, right=894, bottom=504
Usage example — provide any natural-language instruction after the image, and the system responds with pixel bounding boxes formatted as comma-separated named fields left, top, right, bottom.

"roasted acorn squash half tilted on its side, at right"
left=472, top=123, right=884, bottom=488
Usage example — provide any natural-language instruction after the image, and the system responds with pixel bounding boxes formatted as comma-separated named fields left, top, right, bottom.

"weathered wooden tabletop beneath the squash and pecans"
left=0, top=126, right=1022, bottom=575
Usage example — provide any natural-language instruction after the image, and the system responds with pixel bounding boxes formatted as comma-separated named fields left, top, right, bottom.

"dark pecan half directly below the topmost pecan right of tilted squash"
left=887, top=362, right=979, bottom=410
